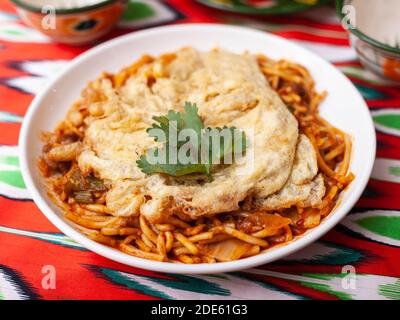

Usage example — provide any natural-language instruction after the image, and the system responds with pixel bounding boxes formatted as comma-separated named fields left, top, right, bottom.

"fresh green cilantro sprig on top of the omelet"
left=137, top=102, right=246, bottom=179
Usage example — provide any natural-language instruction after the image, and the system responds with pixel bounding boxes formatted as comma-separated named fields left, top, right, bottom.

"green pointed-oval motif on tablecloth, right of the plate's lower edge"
left=355, top=216, right=400, bottom=240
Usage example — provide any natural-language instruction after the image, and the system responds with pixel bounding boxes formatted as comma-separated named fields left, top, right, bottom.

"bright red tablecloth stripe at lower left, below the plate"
left=0, top=232, right=159, bottom=300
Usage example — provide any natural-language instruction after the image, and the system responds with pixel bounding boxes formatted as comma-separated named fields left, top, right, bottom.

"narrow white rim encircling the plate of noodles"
left=18, top=23, right=376, bottom=274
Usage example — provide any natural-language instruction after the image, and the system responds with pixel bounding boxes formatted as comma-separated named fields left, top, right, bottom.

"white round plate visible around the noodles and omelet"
left=19, top=24, right=376, bottom=274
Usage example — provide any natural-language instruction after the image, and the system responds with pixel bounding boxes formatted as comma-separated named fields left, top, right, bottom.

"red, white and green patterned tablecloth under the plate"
left=0, top=0, right=400, bottom=300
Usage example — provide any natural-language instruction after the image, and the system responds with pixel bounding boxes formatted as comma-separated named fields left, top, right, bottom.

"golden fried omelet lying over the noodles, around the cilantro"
left=78, top=48, right=325, bottom=223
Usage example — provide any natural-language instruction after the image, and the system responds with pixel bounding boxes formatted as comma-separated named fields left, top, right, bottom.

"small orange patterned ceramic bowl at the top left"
left=11, top=0, right=126, bottom=45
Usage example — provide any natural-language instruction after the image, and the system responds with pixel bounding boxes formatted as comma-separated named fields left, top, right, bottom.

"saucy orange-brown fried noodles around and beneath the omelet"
left=39, top=55, right=354, bottom=264
